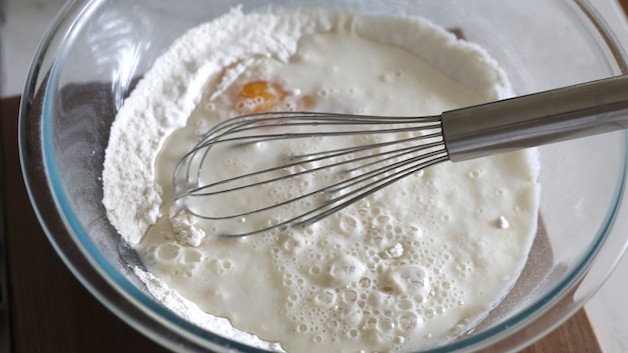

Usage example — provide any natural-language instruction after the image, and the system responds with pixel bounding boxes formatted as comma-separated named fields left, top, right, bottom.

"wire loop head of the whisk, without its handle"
left=173, top=112, right=449, bottom=236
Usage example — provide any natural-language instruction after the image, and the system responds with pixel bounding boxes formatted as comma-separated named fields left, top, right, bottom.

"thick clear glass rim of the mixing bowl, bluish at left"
left=19, top=0, right=628, bottom=353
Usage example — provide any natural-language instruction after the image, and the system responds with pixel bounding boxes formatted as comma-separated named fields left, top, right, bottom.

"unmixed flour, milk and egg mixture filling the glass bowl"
left=103, top=9, right=539, bottom=353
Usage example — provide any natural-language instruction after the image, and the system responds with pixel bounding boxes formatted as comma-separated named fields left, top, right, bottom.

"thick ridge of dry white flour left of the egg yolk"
left=103, top=10, right=336, bottom=243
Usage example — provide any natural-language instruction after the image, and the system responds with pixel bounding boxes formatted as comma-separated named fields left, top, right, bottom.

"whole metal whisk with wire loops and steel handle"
left=173, top=76, right=628, bottom=236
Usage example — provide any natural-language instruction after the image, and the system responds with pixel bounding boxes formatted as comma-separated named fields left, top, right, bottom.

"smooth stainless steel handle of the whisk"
left=441, top=75, right=628, bottom=162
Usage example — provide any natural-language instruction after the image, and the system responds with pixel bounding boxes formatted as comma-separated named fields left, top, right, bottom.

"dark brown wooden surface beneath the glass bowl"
left=0, top=97, right=601, bottom=353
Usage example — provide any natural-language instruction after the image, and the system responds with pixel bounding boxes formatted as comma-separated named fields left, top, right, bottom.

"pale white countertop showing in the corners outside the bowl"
left=0, top=0, right=628, bottom=353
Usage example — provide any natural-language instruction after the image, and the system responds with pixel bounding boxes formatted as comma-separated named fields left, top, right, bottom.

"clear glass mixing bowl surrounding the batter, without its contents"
left=20, top=0, right=628, bottom=352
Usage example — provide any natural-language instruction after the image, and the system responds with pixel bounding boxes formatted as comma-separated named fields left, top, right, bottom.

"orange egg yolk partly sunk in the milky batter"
left=236, top=81, right=286, bottom=114
